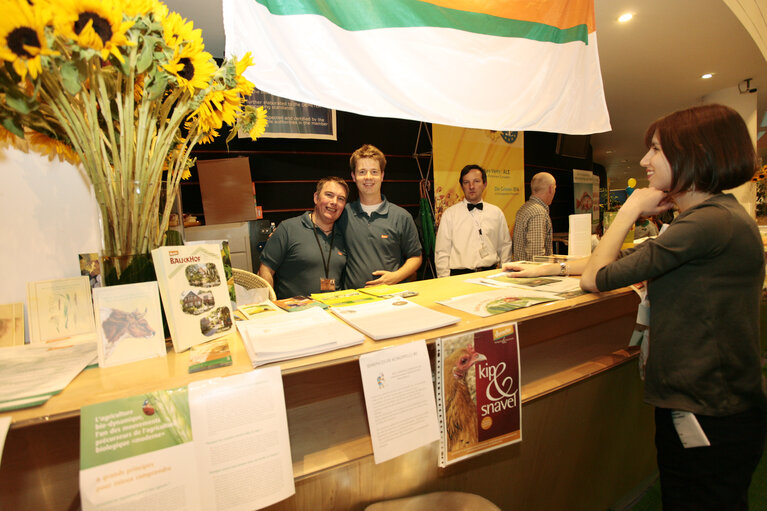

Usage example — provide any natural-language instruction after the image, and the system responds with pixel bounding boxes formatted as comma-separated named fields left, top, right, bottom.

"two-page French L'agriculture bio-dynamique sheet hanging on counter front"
left=80, top=367, right=295, bottom=511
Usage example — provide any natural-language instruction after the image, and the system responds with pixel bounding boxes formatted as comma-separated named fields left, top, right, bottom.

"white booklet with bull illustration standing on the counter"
left=93, top=281, right=166, bottom=367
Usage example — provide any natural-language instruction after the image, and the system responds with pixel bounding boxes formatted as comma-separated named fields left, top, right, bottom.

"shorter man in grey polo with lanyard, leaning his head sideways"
left=258, top=176, right=349, bottom=298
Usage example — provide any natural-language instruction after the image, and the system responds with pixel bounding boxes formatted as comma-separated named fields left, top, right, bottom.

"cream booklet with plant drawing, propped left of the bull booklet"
left=27, top=276, right=96, bottom=344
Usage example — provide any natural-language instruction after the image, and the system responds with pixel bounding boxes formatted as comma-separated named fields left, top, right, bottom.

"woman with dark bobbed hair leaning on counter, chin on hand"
left=504, top=105, right=767, bottom=511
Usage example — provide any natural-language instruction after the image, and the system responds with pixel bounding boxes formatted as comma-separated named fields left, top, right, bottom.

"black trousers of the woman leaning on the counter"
left=655, top=408, right=767, bottom=511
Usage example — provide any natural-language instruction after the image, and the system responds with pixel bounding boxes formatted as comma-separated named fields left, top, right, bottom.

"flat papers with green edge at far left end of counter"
left=0, top=342, right=98, bottom=412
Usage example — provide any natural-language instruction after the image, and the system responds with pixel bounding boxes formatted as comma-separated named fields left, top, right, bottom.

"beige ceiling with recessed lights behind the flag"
left=165, top=0, right=767, bottom=187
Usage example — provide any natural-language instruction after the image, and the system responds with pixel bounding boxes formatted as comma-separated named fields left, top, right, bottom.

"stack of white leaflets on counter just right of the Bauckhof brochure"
left=237, top=307, right=365, bottom=367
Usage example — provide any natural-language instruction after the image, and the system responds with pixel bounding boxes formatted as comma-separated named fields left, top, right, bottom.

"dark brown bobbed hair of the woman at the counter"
left=645, top=104, right=756, bottom=195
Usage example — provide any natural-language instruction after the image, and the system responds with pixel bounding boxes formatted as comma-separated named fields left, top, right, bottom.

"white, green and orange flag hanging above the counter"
left=223, top=0, right=610, bottom=134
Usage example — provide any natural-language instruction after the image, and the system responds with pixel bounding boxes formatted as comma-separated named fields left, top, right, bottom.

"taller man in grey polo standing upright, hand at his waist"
left=338, top=144, right=421, bottom=289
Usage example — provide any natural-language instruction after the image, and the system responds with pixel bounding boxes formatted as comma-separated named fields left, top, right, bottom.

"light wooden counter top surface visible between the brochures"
left=0, top=270, right=632, bottom=428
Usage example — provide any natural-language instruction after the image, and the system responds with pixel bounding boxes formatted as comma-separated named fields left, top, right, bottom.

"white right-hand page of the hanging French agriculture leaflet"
left=189, top=367, right=295, bottom=511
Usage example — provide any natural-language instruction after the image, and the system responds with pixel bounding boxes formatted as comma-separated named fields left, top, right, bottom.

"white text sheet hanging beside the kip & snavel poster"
left=360, top=340, right=439, bottom=463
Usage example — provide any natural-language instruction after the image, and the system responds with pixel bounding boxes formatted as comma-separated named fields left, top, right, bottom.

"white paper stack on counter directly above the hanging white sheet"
left=330, top=298, right=460, bottom=341
